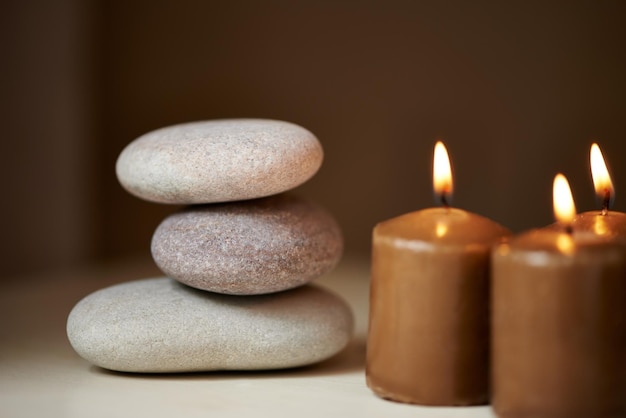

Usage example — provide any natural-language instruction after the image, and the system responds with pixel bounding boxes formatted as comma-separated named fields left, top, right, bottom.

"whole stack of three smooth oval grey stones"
left=67, top=119, right=353, bottom=372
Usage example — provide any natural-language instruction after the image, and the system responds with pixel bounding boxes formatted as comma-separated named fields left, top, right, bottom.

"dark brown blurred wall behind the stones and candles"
left=0, top=0, right=626, bottom=280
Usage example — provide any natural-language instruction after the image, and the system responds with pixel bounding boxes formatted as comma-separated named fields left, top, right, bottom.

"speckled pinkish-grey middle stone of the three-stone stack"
left=151, top=194, right=343, bottom=295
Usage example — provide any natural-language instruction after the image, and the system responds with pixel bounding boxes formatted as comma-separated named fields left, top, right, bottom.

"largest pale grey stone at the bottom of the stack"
left=67, top=278, right=353, bottom=373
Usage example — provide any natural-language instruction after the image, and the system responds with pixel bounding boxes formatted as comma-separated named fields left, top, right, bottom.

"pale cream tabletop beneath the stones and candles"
left=0, top=260, right=493, bottom=418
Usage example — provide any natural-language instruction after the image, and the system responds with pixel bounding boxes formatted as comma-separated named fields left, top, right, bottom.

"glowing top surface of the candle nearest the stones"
left=374, top=207, right=510, bottom=246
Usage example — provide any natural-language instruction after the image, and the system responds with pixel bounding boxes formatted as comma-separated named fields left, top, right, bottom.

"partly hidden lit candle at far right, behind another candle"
left=573, top=143, right=626, bottom=238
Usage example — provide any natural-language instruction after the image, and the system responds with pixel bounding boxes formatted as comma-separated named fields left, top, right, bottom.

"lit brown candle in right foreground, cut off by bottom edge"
left=492, top=176, right=626, bottom=418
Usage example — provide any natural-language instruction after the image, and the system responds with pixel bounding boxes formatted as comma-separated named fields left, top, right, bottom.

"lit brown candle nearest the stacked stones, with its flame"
left=366, top=143, right=509, bottom=405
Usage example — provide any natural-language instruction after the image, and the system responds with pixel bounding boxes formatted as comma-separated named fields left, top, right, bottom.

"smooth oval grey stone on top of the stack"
left=116, top=119, right=323, bottom=204
